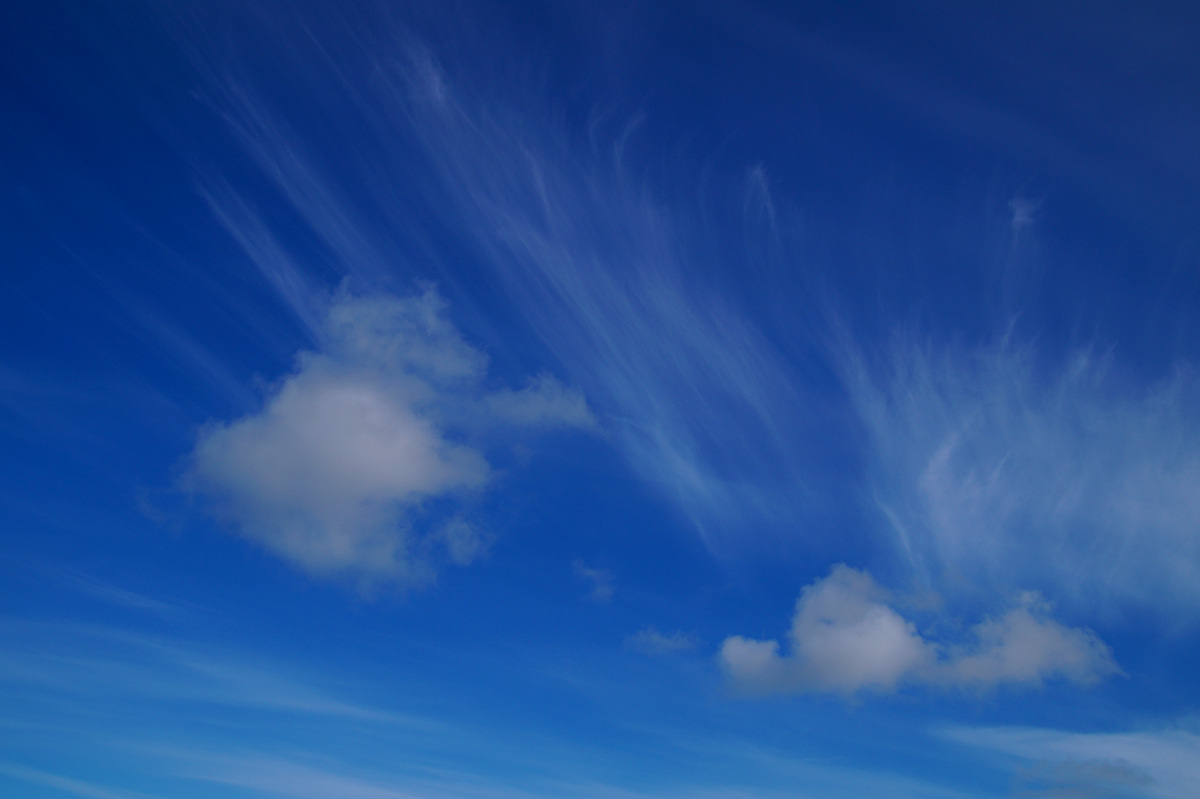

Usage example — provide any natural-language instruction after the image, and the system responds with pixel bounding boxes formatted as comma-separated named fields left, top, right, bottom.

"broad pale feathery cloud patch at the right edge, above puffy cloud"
left=847, top=337, right=1200, bottom=618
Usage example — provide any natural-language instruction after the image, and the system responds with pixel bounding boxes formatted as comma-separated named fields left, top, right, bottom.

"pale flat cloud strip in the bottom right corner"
left=942, top=727, right=1200, bottom=799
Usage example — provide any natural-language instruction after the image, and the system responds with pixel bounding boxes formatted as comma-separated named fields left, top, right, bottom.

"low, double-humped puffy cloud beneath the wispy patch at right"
left=719, top=565, right=1117, bottom=695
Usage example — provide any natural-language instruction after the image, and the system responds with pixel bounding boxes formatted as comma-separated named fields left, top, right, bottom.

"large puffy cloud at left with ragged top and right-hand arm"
left=188, top=283, right=594, bottom=584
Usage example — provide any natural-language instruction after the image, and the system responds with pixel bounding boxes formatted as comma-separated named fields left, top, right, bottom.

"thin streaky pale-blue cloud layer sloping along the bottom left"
left=0, top=621, right=993, bottom=799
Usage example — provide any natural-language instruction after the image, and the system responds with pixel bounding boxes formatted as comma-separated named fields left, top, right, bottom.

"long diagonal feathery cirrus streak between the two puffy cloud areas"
left=396, top=56, right=809, bottom=542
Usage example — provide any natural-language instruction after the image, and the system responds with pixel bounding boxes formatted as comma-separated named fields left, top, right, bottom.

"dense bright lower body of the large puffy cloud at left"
left=194, top=371, right=488, bottom=577
